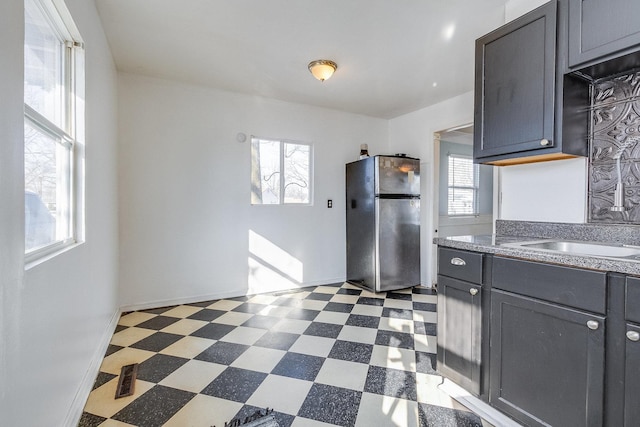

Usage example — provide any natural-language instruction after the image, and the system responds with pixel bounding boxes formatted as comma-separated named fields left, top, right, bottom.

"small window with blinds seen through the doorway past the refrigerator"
left=447, top=154, right=478, bottom=216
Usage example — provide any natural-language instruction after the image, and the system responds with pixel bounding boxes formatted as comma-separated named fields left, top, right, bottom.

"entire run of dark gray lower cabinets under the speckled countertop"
left=438, top=247, right=640, bottom=427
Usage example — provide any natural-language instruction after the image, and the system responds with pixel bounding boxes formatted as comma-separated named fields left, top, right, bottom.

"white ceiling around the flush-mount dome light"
left=96, top=0, right=508, bottom=119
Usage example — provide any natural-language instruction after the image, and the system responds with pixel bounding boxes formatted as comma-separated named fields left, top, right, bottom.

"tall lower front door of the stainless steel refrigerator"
left=376, top=198, right=420, bottom=292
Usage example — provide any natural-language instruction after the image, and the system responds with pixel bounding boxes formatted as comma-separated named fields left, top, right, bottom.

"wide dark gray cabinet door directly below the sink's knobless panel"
left=489, top=289, right=604, bottom=427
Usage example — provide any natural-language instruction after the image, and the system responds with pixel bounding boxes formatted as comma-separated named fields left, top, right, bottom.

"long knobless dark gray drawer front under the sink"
left=492, top=257, right=607, bottom=314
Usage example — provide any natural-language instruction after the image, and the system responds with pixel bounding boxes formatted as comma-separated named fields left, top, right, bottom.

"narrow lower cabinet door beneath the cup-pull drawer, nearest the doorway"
left=438, top=276, right=482, bottom=395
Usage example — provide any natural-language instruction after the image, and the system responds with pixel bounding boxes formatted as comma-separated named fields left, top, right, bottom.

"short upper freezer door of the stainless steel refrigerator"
left=374, top=156, right=420, bottom=195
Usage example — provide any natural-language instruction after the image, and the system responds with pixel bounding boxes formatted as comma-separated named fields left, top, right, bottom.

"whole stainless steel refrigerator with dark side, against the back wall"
left=346, top=155, right=420, bottom=292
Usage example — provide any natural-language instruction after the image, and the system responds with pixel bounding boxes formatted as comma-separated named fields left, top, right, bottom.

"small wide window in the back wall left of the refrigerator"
left=251, top=138, right=312, bottom=205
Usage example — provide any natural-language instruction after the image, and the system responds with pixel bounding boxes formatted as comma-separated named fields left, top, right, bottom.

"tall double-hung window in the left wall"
left=24, top=0, right=83, bottom=259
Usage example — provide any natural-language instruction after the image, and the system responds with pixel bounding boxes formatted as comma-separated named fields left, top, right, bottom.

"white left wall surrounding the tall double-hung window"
left=0, top=0, right=117, bottom=426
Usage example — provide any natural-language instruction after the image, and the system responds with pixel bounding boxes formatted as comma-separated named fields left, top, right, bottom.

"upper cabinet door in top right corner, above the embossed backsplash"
left=569, top=0, right=640, bottom=68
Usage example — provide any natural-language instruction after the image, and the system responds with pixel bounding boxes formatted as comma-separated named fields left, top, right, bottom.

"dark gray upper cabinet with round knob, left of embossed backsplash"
left=474, top=0, right=589, bottom=165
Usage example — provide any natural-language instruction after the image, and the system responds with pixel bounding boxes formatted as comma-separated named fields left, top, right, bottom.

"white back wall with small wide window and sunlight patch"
left=119, top=74, right=388, bottom=307
